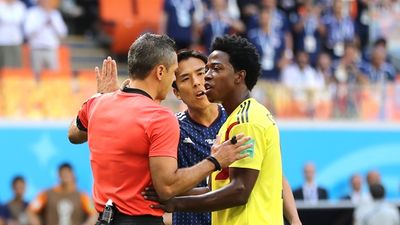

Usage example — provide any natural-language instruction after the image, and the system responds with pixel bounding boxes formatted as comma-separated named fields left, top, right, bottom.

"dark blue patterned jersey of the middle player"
left=172, top=106, right=227, bottom=225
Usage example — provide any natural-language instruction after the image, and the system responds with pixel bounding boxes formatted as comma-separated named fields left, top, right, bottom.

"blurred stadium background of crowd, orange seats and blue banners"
left=0, top=0, right=400, bottom=224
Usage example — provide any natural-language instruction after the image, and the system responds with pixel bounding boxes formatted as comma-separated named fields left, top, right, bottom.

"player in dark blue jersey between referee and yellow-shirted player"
left=172, top=50, right=227, bottom=225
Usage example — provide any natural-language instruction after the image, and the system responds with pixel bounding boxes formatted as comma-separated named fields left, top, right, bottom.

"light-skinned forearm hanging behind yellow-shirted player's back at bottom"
left=282, top=177, right=301, bottom=224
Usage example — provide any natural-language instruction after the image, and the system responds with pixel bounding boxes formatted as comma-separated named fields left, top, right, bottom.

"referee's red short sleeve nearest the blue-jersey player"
left=146, top=110, right=179, bottom=158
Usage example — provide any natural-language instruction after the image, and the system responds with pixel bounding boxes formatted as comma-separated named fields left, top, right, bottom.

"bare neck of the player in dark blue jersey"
left=188, top=104, right=219, bottom=127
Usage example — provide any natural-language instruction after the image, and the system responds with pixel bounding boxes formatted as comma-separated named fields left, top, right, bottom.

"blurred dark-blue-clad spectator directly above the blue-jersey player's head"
left=159, top=0, right=199, bottom=49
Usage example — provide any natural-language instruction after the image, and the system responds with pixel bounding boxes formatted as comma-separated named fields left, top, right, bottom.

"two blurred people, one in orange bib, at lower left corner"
left=0, top=163, right=97, bottom=225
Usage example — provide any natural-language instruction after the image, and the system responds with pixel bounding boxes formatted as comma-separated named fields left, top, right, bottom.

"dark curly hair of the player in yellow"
left=211, top=35, right=261, bottom=90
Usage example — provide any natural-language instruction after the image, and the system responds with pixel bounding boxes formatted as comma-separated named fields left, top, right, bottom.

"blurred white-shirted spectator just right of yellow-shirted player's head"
left=282, top=51, right=325, bottom=117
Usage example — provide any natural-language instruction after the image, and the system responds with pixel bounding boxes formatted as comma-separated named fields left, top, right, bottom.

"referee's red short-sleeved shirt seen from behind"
left=78, top=88, right=179, bottom=216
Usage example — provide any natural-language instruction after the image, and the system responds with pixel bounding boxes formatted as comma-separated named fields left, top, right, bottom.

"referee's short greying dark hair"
left=128, top=33, right=175, bottom=80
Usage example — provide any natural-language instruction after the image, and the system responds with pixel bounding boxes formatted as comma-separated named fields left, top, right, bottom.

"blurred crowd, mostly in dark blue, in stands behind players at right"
left=160, top=0, right=400, bottom=119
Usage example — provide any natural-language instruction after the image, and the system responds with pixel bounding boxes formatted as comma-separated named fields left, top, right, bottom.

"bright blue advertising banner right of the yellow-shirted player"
left=281, top=122, right=400, bottom=199
